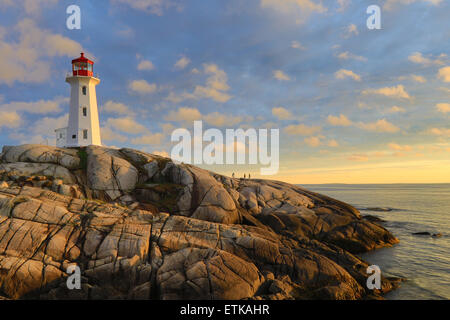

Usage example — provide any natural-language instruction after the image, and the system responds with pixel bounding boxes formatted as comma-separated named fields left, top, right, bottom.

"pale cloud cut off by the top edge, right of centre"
left=260, top=0, right=327, bottom=24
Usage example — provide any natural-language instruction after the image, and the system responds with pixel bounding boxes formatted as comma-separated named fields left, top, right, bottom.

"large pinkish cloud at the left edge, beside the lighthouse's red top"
left=0, top=18, right=83, bottom=85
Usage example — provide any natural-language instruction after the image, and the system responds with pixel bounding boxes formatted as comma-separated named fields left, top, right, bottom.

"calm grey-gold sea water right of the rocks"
left=301, top=184, right=450, bottom=300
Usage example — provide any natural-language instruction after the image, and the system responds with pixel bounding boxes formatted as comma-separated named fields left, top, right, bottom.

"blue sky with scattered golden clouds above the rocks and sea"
left=0, top=0, right=450, bottom=184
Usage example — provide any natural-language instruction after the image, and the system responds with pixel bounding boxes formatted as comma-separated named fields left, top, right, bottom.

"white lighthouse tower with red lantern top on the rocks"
left=55, top=53, right=102, bottom=147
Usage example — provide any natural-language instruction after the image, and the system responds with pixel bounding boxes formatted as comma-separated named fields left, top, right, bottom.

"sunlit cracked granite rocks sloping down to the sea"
left=0, top=145, right=399, bottom=299
